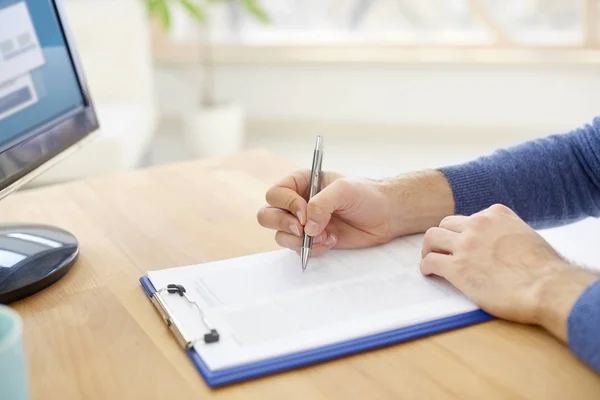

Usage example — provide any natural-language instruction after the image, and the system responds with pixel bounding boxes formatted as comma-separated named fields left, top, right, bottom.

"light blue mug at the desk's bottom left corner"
left=0, top=305, right=29, bottom=400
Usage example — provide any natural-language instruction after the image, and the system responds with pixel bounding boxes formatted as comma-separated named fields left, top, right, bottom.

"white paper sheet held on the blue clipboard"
left=149, top=236, right=477, bottom=370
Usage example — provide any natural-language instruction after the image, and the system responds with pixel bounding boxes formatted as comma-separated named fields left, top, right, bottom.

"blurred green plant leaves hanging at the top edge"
left=143, top=0, right=269, bottom=31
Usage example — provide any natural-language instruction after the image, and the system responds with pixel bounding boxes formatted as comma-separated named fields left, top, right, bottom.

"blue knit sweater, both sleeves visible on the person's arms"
left=441, top=117, right=600, bottom=373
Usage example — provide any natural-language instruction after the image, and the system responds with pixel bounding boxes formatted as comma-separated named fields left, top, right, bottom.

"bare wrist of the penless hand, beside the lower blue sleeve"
left=534, top=263, right=598, bottom=342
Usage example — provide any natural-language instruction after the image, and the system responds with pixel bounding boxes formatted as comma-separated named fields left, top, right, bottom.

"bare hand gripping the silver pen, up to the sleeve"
left=257, top=171, right=454, bottom=255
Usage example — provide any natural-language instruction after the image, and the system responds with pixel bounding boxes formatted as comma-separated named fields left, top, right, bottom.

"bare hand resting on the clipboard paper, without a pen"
left=421, top=205, right=596, bottom=340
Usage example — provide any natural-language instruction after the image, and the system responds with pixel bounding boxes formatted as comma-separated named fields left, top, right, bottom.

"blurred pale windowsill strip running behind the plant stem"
left=153, top=41, right=600, bottom=65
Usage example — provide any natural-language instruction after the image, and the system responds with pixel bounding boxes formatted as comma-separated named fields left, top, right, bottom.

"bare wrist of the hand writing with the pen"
left=381, top=170, right=454, bottom=236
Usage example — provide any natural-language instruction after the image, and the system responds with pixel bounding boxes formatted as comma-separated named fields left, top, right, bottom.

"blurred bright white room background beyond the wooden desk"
left=30, top=0, right=600, bottom=184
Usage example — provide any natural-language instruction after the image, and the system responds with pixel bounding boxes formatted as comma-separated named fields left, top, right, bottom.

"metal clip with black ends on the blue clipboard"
left=151, top=284, right=219, bottom=350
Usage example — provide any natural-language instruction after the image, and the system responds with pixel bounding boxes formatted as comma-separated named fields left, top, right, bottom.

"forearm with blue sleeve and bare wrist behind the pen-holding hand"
left=384, top=118, right=600, bottom=233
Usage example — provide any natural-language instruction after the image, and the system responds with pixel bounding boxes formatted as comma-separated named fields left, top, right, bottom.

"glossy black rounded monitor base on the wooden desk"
left=0, top=225, right=79, bottom=304
